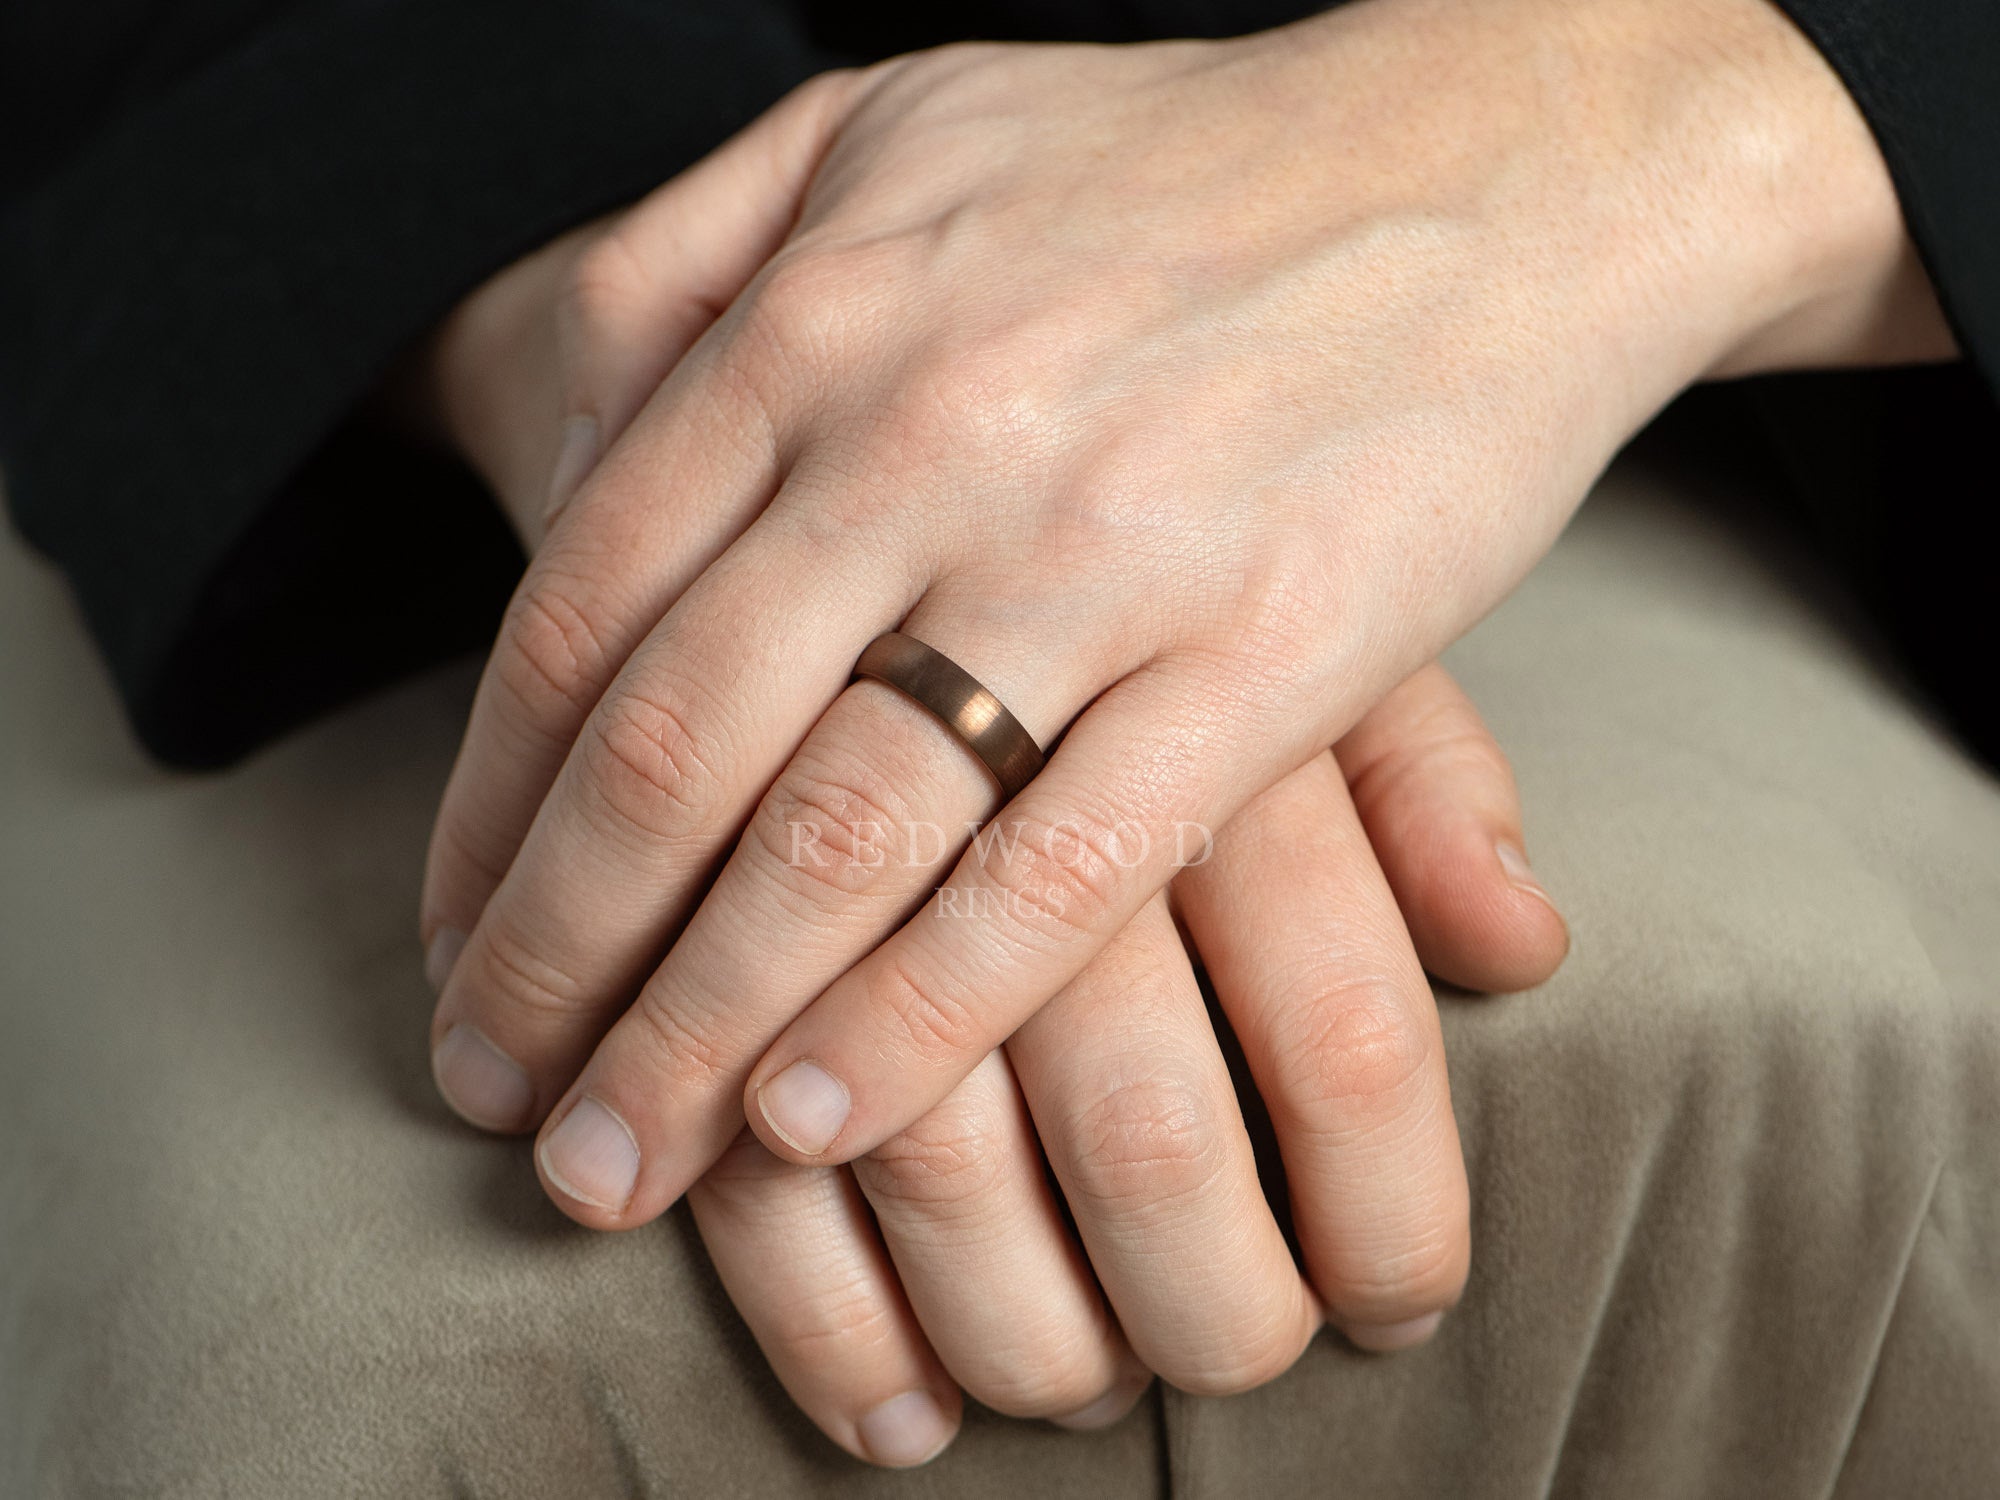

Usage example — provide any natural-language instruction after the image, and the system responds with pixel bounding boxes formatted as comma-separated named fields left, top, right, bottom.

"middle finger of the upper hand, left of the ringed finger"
left=432, top=506, right=916, bottom=1136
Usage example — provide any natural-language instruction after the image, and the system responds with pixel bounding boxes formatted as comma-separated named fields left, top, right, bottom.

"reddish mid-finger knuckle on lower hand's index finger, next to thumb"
left=1278, top=976, right=1436, bottom=1118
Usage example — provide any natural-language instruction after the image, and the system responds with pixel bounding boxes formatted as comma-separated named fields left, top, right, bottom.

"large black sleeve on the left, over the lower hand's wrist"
left=0, top=0, right=826, bottom=764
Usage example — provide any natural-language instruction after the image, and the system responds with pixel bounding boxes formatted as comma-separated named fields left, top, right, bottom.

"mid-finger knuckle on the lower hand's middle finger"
left=1062, top=1072, right=1222, bottom=1214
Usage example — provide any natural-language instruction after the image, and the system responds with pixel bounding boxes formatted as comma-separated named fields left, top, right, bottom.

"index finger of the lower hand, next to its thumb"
left=1180, top=754, right=1470, bottom=1348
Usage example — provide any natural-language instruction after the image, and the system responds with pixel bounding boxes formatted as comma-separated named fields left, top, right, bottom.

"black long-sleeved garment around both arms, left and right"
left=0, top=0, right=2000, bottom=764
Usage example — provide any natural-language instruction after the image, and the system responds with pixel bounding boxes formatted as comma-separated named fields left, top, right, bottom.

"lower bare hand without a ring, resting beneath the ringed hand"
left=404, top=114, right=1566, bottom=1462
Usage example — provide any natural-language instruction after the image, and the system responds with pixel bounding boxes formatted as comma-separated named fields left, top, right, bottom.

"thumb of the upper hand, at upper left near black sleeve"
left=544, top=70, right=864, bottom=526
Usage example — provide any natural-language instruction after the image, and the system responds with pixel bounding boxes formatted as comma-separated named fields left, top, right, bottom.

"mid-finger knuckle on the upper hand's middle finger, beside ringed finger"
left=580, top=690, right=720, bottom=840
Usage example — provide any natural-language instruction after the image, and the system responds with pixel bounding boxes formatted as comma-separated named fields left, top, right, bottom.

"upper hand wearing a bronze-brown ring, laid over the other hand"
left=426, top=0, right=1920, bottom=1256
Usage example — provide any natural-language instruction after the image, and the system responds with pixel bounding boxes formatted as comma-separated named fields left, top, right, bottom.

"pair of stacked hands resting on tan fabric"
left=402, top=0, right=1922, bottom=1462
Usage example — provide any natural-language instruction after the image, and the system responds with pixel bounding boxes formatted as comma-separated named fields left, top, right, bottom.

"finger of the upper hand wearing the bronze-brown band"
left=532, top=596, right=1110, bottom=1228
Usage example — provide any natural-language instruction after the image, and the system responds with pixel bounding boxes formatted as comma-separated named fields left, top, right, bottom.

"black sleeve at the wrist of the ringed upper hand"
left=1744, top=0, right=2000, bottom=766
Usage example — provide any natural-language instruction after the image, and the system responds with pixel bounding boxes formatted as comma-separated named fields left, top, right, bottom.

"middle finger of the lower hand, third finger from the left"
left=1008, top=898, right=1320, bottom=1396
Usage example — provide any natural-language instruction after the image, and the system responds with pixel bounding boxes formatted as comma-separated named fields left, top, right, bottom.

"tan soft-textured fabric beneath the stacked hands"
left=0, top=444, right=2000, bottom=1500
